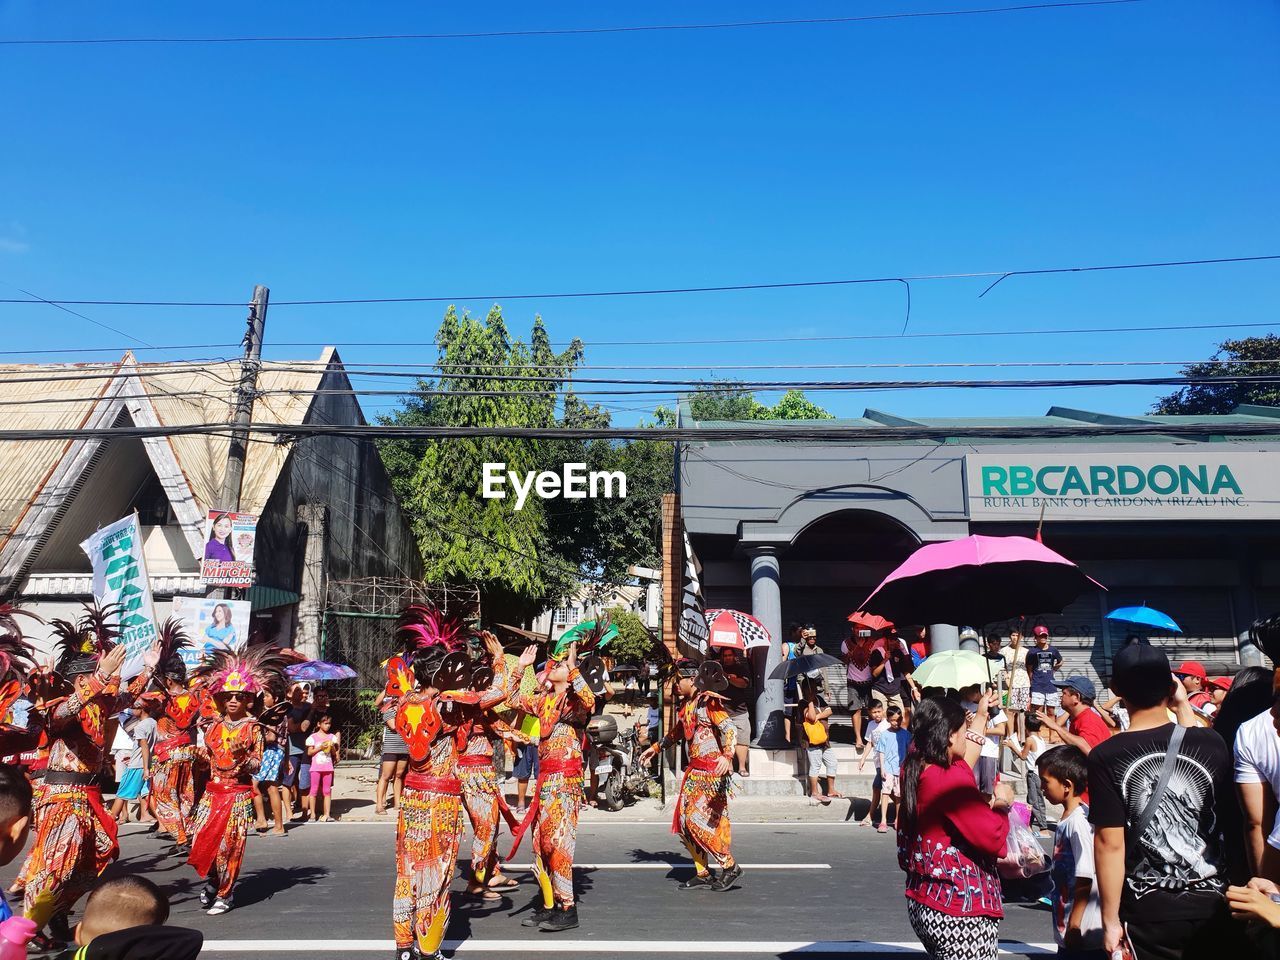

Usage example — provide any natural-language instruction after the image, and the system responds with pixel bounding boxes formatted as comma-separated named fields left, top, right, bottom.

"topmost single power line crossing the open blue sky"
left=0, top=0, right=1142, bottom=46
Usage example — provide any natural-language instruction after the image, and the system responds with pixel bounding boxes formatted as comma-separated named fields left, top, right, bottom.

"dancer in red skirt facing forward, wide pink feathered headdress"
left=187, top=646, right=288, bottom=916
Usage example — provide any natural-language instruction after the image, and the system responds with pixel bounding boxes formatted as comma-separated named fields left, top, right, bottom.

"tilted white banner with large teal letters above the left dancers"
left=81, top=513, right=156, bottom=680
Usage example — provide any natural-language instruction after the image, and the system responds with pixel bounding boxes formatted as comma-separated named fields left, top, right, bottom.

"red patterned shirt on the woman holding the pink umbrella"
left=897, top=760, right=1009, bottom=918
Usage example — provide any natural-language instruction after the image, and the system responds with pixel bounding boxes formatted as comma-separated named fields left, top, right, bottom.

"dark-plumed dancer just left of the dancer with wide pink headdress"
left=147, top=617, right=200, bottom=855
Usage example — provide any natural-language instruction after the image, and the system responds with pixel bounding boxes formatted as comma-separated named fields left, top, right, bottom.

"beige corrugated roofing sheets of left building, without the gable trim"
left=0, top=347, right=334, bottom=539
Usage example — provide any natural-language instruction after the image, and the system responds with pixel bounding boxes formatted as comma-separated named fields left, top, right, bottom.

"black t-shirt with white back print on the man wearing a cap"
left=1089, top=723, right=1235, bottom=923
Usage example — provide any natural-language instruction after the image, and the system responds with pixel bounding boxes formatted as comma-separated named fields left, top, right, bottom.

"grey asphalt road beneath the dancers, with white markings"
left=4, top=813, right=1053, bottom=960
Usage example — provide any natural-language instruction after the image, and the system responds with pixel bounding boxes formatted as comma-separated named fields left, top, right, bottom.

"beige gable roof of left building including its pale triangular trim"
left=0, top=347, right=340, bottom=589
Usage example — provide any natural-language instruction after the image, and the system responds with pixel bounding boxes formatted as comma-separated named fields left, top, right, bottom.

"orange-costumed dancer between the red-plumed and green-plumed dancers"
left=456, top=631, right=529, bottom=900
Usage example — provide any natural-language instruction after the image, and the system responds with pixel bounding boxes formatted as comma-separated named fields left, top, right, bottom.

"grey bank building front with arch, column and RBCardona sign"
left=677, top=407, right=1280, bottom=747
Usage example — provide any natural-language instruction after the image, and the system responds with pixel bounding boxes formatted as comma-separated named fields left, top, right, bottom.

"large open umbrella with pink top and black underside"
left=863, top=536, right=1106, bottom=626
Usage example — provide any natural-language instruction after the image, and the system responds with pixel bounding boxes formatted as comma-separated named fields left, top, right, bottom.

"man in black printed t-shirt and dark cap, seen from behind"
left=1088, top=644, right=1252, bottom=960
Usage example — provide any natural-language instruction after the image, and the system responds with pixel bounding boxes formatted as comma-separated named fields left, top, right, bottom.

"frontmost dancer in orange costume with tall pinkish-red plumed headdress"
left=392, top=607, right=481, bottom=960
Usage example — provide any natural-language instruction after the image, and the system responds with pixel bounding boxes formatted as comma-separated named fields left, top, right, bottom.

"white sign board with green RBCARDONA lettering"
left=965, top=455, right=1280, bottom=521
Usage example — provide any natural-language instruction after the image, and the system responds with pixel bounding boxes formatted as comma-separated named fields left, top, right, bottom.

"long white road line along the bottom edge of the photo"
left=205, top=937, right=1057, bottom=956
